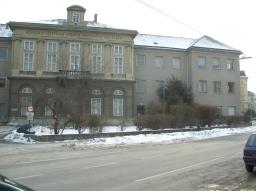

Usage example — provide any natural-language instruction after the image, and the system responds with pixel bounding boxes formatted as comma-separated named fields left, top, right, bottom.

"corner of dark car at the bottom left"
left=0, top=175, right=34, bottom=191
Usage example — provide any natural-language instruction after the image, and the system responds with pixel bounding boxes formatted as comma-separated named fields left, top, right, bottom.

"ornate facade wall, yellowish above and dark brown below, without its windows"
left=9, top=14, right=137, bottom=124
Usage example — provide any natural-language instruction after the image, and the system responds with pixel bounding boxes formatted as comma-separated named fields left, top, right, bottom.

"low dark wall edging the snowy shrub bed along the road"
left=24, top=126, right=232, bottom=142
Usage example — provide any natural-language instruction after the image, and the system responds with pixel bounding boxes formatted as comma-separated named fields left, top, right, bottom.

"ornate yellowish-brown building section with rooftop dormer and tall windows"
left=4, top=6, right=137, bottom=122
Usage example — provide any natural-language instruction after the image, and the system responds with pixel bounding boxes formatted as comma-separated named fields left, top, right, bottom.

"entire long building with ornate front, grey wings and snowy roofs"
left=0, top=5, right=241, bottom=124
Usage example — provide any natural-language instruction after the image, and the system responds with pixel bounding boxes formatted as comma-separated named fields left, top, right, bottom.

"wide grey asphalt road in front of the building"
left=0, top=134, right=256, bottom=191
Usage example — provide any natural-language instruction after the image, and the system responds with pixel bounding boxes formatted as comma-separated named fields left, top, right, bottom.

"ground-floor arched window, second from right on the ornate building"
left=91, top=89, right=102, bottom=115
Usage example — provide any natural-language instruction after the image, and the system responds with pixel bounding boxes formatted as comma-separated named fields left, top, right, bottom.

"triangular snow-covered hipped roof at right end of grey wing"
left=192, top=36, right=236, bottom=50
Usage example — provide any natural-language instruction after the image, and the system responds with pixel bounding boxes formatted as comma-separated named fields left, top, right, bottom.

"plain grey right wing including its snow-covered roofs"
left=134, top=34, right=241, bottom=116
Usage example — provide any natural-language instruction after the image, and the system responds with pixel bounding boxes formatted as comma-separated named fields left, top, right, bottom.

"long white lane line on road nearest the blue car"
left=135, top=156, right=225, bottom=182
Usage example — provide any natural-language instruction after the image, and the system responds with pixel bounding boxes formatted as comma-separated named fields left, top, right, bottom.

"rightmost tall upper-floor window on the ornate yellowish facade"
left=113, top=46, right=124, bottom=74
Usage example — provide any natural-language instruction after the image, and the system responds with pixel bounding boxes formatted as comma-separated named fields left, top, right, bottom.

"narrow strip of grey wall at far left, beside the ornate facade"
left=0, top=38, right=12, bottom=122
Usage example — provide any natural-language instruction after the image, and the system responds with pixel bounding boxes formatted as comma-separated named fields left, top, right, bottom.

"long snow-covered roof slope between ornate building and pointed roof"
left=134, top=34, right=196, bottom=49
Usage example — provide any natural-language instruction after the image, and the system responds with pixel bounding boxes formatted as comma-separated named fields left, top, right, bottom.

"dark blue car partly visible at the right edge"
left=243, top=134, right=256, bottom=172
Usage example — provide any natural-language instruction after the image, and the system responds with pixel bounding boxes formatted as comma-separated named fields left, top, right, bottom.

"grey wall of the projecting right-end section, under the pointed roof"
left=189, top=50, right=241, bottom=115
